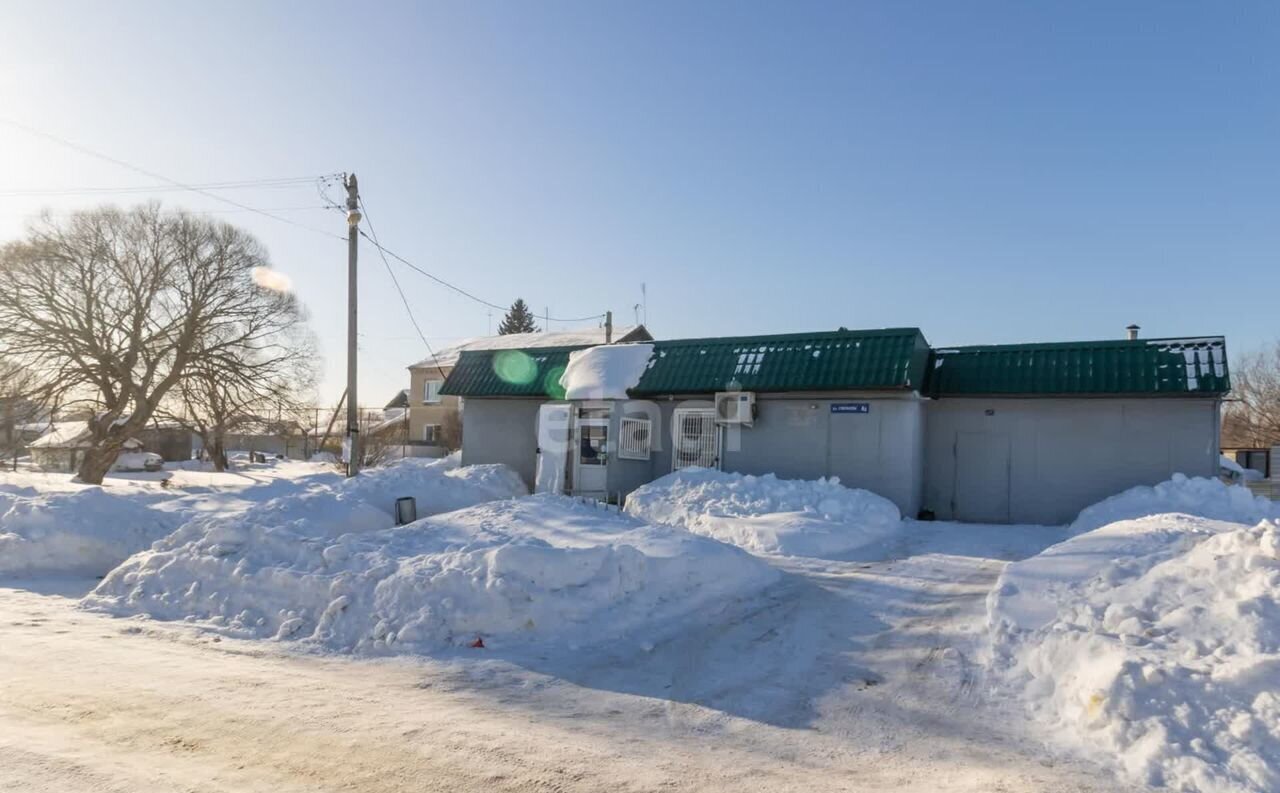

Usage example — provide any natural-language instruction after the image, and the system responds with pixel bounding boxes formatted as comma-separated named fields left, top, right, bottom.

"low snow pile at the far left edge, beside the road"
left=0, top=487, right=180, bottom=576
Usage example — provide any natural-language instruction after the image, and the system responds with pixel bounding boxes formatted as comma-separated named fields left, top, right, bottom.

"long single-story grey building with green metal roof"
left=440, top=327, right=1230, bottom=523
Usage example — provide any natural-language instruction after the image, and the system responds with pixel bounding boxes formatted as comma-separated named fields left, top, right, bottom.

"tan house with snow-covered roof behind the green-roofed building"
left=407, top=325, right=653, bottom=451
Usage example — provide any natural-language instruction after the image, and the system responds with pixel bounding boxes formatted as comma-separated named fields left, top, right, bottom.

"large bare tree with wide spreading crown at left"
left=0, top=205, right=317, bottom=483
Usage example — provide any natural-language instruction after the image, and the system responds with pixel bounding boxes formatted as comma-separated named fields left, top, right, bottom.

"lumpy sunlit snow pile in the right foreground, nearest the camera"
left=1004, top=515, right=1280, bottom=793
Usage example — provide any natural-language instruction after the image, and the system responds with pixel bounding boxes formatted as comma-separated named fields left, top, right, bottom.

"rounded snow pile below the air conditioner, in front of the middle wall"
left=626, top=468, right=902, bottom=556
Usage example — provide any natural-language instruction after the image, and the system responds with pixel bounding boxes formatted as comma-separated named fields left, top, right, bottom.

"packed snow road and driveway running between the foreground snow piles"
left=0, top=523, right=1141, bottom=793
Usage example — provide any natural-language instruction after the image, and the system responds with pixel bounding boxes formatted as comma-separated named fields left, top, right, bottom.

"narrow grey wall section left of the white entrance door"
left=462, top=398, right=544, bottom=490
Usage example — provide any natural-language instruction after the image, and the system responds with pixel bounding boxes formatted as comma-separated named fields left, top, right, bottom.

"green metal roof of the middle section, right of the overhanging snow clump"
left=630, top=327, right=929, bottom=397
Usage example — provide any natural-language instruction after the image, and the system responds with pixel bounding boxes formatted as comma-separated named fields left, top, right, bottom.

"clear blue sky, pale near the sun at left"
left=0, top=0, right=1280, bottom=404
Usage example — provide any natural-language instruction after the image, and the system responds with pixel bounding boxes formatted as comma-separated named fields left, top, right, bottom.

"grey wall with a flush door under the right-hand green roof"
left=924, top=398, right=1220, bottom=524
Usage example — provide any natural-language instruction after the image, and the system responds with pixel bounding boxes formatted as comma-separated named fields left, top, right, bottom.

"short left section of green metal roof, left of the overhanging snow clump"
left=440, top=347, right=585, bottom=399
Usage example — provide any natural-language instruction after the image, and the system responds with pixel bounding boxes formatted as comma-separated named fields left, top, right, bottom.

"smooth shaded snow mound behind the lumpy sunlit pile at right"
left=1071, top=473, right=1280, bottom=533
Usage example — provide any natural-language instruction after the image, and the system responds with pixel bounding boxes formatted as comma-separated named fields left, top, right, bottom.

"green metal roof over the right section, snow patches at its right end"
left=925, top=336, right=1231, bottom=397
